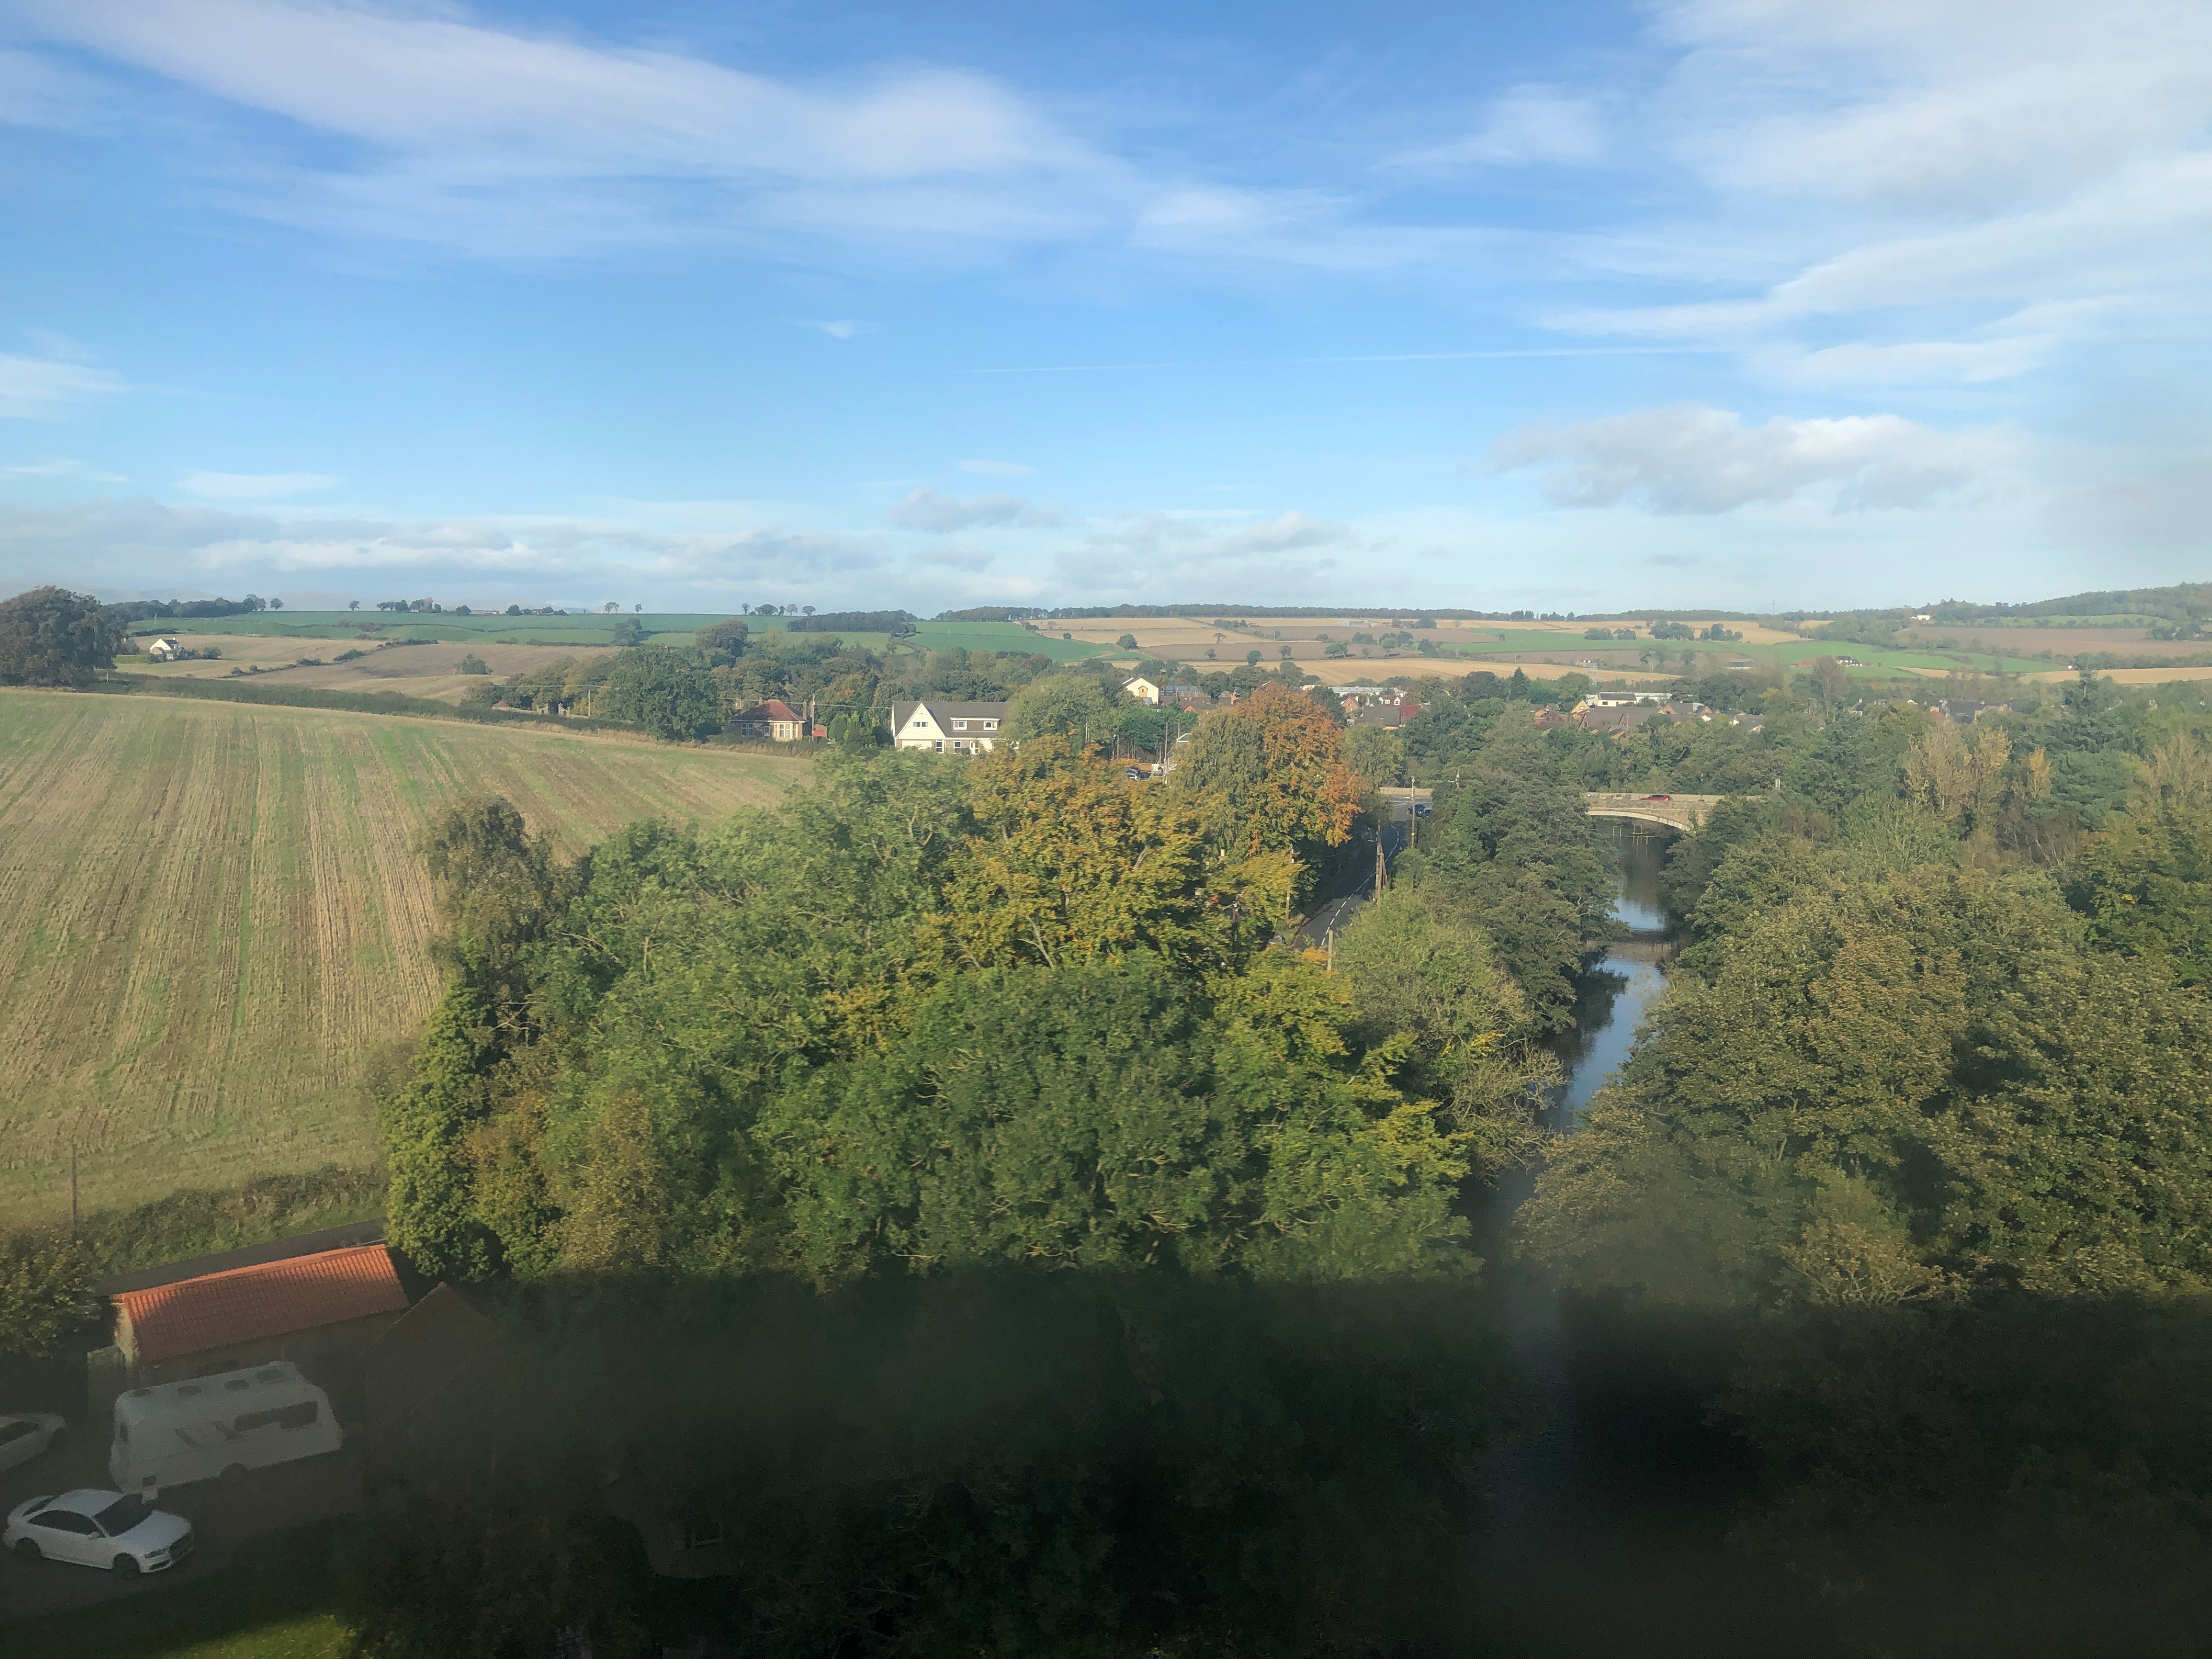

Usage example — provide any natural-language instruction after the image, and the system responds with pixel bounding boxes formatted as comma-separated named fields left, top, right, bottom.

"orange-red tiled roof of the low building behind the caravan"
left=115, top=1245, right=407, bottom=1361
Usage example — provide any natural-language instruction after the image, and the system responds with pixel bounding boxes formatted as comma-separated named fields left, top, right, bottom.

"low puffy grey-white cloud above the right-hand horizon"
left=1484, top=403, right=2017, bottom=513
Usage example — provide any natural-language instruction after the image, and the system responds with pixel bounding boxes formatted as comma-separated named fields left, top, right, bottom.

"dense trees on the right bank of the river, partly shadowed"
left=1520, top=695, right=2212, bottom=1652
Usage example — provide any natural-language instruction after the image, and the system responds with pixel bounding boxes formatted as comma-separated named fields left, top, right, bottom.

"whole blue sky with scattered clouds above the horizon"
left=0, top=0, right=2212, bottom=615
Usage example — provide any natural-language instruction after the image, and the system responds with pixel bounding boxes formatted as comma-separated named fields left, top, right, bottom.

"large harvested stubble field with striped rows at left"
left=0, top=690, right=805, bottom=1221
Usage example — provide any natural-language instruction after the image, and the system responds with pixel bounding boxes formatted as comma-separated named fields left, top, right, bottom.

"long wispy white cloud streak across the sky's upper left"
left=24, top=0, right=1126, bottom=259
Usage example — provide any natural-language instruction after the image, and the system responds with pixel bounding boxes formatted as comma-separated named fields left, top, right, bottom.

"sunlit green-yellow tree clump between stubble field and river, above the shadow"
left=385, top=737, right=1498, bottom=1283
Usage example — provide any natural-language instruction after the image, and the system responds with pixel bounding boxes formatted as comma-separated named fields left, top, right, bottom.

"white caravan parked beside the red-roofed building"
left=109, top=1361, right=345, bottom=1493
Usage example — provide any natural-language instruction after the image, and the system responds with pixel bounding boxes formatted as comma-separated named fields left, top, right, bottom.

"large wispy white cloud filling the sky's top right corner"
left=1546, top=0, right=2212, bottom=387
